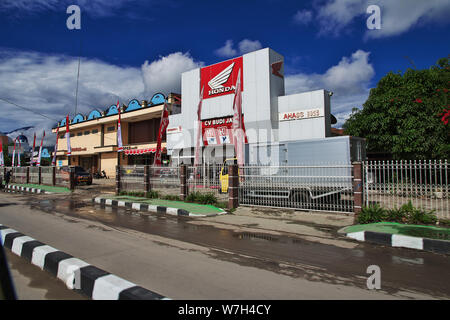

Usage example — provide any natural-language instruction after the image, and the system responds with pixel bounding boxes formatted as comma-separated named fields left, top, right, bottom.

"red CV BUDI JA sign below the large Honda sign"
left=202, top=116, right=248, bottom=146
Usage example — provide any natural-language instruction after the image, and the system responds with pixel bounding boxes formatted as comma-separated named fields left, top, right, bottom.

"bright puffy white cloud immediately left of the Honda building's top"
left=141, top=52, right=203, bottom=95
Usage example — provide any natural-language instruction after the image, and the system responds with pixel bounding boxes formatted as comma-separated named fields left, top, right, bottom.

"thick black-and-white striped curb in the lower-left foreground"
left=0, top=224, right=170, bottom=300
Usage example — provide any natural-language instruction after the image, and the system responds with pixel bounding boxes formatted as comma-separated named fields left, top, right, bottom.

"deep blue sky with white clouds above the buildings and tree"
left=0, top=0, right=450, bottom=145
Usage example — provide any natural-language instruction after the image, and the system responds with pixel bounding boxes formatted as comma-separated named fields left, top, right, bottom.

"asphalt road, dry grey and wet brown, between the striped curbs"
left=0, top=193, right=450, bottom=300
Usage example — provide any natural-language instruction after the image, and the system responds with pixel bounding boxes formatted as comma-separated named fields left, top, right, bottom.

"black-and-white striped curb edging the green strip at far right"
left=346, top=231, right=450, bottom=254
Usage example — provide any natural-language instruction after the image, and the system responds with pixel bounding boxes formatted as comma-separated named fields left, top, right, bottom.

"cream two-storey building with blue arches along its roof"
left=52, top=93, right=180, bottom=178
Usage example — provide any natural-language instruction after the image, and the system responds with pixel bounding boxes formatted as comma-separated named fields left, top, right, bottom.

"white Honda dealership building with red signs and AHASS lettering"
left=167, top=48, right=331, bottom=164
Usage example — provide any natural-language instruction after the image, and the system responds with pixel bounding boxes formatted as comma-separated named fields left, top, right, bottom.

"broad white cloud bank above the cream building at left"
left=0, top=50, right=198, bottom=145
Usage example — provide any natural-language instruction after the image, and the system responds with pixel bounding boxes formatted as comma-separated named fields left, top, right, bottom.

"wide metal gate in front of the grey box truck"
left=239, top=164, right=353, bottom=212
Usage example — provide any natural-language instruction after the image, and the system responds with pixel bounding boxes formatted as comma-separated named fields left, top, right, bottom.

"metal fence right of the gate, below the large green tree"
left=363, top=160, right=450, bottom=219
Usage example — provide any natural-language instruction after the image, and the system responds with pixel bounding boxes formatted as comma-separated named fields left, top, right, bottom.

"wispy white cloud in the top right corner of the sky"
left=317, top=0, right=450, bottom=38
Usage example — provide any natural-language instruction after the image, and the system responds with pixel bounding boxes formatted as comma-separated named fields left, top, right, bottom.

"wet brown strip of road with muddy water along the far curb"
left=12, top=190, right=450, bottom=298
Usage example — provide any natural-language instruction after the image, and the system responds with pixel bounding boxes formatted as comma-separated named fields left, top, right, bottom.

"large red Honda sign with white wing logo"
left=200, top=57, right=244, bottom=99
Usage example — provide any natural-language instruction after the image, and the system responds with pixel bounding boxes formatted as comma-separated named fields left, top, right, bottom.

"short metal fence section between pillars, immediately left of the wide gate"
left=187, top=164, right=228, bottom=201
